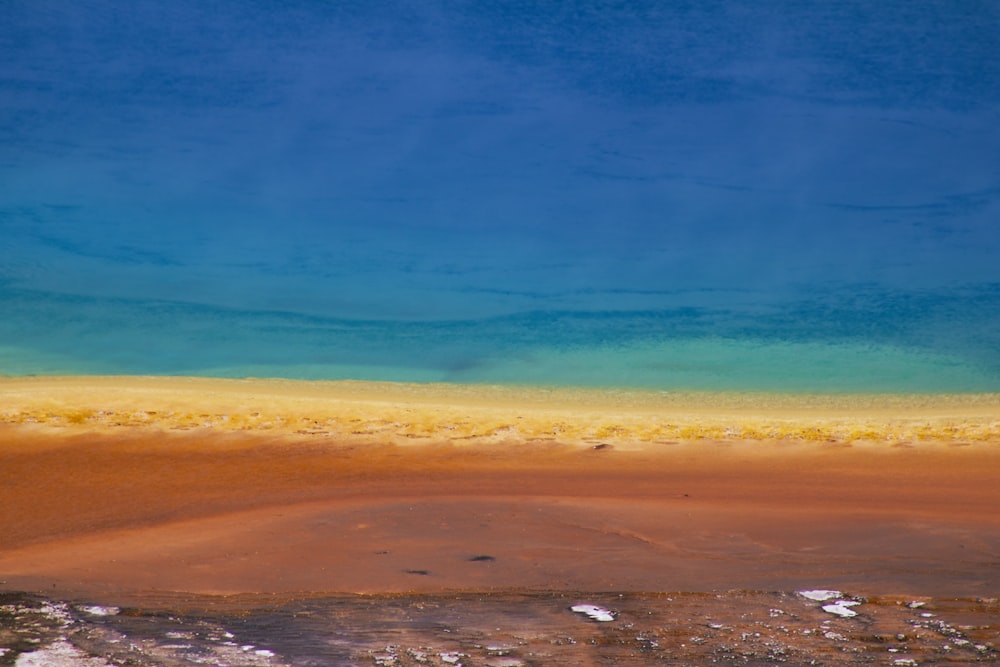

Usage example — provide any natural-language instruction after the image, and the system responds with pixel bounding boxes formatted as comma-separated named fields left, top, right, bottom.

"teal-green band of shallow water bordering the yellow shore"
left=0, top=282, right=1000, bottom=393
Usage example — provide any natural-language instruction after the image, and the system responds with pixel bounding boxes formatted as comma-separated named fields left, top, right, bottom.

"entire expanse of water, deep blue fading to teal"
left=0, top=0, right=1000, bottom=392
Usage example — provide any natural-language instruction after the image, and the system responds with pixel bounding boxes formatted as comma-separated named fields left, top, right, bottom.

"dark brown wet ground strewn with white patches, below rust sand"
left=0, top=591, right=1000, bottom=667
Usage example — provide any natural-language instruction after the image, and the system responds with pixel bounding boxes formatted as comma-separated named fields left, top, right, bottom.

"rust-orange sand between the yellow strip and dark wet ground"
left=0, top=425, right=1000, bottom=596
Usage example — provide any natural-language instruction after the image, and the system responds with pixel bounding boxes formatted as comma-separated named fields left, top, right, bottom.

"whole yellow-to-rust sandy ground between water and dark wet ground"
left=0, top=378, right=1000, bottom=596
